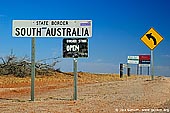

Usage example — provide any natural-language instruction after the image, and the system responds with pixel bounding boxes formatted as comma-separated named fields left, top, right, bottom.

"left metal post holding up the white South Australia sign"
left=31, top=37, right=35, bottom=101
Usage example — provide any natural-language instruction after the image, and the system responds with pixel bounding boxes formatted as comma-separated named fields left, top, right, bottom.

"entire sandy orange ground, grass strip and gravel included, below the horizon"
left=0, top=72, right=170, bottom=113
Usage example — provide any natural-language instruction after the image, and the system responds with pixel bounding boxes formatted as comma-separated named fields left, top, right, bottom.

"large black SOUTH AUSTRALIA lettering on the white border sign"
left=15, top=27, right=90, bottom=37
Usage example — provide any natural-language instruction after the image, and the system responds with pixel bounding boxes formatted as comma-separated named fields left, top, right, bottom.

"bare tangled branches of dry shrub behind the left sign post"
left=0, top=52, right=60, bottom=77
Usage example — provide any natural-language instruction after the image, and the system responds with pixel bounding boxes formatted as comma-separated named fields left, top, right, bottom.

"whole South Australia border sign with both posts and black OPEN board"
left=12, top=20, right=92, bottom=101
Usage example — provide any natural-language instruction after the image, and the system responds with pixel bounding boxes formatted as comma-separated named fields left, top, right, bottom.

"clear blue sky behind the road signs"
left=0, top=0, right=170, bottom=76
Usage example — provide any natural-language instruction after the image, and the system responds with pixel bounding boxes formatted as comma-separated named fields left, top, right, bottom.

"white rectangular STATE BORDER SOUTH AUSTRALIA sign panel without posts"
left=12, top=20, right=92, bottom=38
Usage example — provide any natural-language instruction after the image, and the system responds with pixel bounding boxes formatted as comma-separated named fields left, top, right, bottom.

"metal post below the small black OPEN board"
left=73, top=58, right=77, bottom=100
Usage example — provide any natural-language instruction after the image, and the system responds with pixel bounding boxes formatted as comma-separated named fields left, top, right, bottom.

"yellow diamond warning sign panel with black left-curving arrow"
left=141, top=28, right=164, bottom=50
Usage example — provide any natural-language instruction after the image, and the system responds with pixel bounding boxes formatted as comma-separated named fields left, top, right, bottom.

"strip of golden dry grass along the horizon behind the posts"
left=0, top=72, right=150, bottom=87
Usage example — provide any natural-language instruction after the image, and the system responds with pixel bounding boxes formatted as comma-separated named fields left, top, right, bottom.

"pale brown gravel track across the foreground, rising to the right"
left=0, top=74, right=170, bottom=113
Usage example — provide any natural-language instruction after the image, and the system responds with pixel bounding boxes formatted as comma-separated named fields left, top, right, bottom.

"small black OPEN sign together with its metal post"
left=63, top=38, right=88, bottom=100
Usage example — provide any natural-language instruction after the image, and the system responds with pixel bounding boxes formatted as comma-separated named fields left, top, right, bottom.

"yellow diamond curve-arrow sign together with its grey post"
left=141, top=28, right=164, bottom=80
